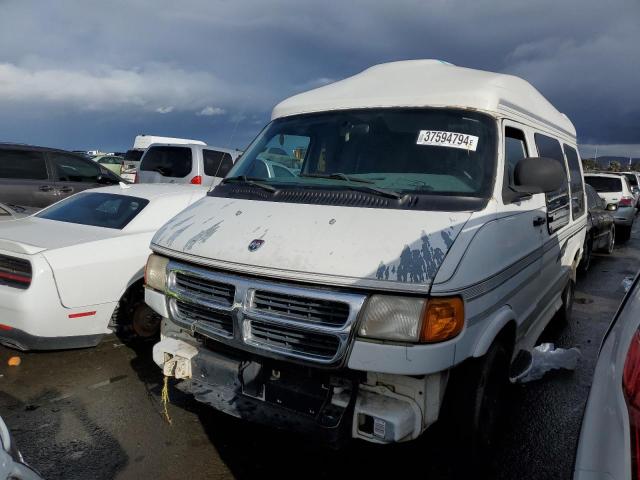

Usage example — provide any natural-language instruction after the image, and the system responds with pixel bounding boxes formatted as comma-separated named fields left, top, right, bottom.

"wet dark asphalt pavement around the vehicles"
left=0, top=222, right=640, bottom=480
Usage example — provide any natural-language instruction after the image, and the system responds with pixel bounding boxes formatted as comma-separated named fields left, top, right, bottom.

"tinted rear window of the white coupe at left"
left=36, top=192, right=149, bottom=230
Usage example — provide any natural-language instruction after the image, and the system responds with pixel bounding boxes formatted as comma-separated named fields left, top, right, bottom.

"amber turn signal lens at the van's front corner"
left=420, top=297, right=464, bottom=343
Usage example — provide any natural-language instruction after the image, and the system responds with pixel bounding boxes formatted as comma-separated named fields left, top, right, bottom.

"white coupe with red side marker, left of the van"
left=0, top=184, right=206, bottom=350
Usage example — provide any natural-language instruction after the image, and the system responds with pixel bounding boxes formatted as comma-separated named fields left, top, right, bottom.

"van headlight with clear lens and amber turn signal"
left=358, top=295, right=464, bottom=343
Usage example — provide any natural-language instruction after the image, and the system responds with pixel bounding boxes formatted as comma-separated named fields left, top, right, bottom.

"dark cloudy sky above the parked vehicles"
left=0, top=0, right=640, bottom=148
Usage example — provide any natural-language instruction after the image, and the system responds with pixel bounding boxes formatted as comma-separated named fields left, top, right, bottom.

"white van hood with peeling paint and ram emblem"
left=152, top=197, right=471, bottom=292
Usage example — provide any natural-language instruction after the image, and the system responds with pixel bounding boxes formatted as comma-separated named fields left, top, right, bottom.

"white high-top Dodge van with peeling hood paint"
left=146, top=60, right=586, bottom=445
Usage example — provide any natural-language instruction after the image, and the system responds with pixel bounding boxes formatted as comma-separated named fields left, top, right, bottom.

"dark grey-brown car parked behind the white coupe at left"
left=0, top=143, right=122, bottom=208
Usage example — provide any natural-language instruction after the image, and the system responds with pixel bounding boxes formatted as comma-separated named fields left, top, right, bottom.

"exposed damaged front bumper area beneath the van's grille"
left=153, top=334, right=446, bottom=444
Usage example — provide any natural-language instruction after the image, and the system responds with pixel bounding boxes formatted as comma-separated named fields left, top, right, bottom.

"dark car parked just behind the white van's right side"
left=580, top=184, right=618, bottom=272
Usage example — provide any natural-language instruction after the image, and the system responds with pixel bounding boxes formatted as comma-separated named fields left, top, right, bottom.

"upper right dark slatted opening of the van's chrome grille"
left=253, top=290, right=349, bottom=327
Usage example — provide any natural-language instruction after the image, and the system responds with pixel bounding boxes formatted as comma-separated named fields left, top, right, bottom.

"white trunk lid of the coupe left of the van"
left=0, top=217, right=120, bottom=255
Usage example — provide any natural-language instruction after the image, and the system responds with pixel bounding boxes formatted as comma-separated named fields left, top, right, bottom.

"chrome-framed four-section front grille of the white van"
left=167, top=261, right=366, bottom=365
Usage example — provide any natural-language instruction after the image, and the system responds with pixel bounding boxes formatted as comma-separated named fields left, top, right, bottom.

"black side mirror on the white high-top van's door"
left=513, top=157, right=567, bottom=194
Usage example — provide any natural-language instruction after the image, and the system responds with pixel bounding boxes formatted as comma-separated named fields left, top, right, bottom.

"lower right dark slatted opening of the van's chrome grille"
left=251, top=320, right=340, bottom=360
